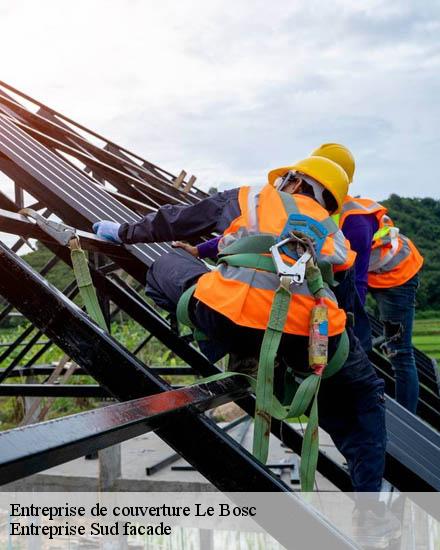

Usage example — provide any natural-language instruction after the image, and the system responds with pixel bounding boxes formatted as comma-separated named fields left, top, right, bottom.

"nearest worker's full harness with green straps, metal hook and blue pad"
left=177, top=215, right=349, bottom=491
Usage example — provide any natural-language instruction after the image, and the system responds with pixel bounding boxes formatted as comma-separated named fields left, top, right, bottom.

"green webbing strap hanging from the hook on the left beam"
left=69, top=239, right=107, bottom=330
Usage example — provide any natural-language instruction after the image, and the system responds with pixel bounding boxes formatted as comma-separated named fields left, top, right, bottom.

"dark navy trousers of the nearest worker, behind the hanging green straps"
left=147, top=251, right=386, bottom=491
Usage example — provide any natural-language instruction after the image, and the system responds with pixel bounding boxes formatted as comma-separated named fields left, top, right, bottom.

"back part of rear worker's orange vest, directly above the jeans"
left=368, top=215, right=423, bottom=288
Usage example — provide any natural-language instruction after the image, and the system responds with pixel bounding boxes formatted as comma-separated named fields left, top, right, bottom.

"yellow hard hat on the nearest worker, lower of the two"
left=268, top=156, right=348, bottom=213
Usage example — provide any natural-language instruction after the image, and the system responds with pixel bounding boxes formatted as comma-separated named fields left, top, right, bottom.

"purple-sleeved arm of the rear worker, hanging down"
left=342, top=214, right=378, bottom=304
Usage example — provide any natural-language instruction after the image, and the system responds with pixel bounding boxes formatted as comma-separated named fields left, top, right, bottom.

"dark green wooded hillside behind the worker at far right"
left=382, top=195, right=440, bottom=313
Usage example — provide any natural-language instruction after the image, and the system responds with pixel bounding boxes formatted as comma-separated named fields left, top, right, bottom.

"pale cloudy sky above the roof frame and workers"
left=0, top=0, right=440, bottom=200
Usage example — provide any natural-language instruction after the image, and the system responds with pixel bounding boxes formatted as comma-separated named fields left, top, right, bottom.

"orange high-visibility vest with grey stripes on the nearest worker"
left=194, top=185, right=356, bottom=336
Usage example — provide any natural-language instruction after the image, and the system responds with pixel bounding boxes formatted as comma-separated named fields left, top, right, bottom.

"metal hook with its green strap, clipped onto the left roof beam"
left=19, top=208, right=107, bottom=330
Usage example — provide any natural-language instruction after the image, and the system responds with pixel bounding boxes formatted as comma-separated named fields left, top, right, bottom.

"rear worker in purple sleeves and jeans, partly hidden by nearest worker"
left=312, top=143, right=423, bottom=413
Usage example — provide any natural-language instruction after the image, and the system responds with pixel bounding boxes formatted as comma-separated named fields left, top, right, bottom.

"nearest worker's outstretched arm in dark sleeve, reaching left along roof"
left=109, top=189, right=240, bottom=244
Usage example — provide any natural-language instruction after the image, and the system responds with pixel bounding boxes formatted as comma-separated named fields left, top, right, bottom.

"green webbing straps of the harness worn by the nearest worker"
left=177, top=252, right=349, bottom=491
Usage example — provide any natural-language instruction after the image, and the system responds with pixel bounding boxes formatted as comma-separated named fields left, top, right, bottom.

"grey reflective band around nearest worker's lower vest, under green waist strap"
left=217, top=264, right=337, bottom=303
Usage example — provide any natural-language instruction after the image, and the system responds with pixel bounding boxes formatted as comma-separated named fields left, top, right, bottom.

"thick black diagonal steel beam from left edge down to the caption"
left=0, top=243, right=353, bottom=549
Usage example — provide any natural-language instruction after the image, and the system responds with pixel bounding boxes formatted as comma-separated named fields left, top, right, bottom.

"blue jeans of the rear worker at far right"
left=370, top=275, right=419, bottom=413
